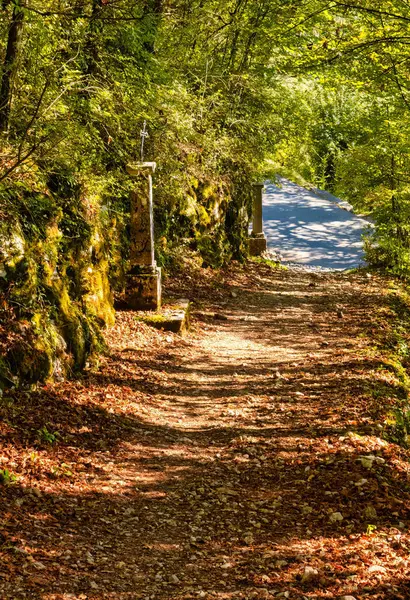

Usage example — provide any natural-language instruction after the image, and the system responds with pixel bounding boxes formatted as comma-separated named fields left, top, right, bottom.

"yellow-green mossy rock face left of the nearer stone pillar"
left=0, top=168, right=117, bottom=385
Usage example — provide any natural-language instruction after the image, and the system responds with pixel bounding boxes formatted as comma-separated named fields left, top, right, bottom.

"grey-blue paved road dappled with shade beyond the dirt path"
left=263, top=179, right=369, bottom=270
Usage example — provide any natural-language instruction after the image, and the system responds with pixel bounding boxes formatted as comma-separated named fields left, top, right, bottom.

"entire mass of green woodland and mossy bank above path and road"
left=0, top=0, right=410, bottom=380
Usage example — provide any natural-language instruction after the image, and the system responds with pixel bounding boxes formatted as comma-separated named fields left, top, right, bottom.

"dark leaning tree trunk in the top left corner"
left=0, top=0, right=27, bottom=131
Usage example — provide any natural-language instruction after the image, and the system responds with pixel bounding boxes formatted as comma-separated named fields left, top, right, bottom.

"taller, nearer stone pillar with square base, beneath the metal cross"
left=126, top=162, right=161, bottom=310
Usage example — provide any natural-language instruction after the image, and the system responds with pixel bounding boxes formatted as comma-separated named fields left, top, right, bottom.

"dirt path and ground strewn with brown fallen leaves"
left=0, top=263, right=410, bottom=600
